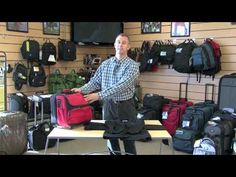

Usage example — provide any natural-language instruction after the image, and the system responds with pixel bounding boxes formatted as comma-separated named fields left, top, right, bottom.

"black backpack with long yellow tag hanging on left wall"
left=20, top=39, right=40, bottom=62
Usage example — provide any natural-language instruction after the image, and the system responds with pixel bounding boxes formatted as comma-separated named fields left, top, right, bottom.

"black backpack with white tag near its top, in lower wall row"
left=29, top=65, right=46, bottom=87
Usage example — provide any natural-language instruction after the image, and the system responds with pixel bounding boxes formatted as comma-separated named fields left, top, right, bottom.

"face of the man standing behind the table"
left=114, top=36, right=130, bottom=55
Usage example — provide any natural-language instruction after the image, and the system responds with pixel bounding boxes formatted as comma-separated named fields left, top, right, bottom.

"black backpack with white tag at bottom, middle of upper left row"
left=40, top=41, right=57, bottom=65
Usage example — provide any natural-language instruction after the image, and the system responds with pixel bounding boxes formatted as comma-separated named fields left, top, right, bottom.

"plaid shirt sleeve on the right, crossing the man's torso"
left=98, top=60, right=140, bottom=99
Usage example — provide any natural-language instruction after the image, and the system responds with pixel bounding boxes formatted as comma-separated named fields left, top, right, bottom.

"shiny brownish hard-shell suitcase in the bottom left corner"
left=0, top=111, right=27, bottom=155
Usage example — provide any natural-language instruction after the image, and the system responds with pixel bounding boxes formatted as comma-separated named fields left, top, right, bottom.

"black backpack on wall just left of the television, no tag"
left=58, top=39, right=76, bottom=61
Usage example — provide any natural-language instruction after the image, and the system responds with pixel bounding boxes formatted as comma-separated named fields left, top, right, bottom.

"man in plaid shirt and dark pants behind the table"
left=72, top=33, right=139, bottom=154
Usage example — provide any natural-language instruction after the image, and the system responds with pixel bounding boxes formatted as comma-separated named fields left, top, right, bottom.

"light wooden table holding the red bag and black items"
left=44, top=120, right=171, bottom=154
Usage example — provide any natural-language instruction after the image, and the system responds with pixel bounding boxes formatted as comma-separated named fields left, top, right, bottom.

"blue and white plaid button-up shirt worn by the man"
left=80, top=57, right=139, bottom=101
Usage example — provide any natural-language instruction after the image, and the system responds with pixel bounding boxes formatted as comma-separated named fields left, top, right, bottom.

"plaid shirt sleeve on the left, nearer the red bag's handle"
left=80, top=65, right=102, bottom=94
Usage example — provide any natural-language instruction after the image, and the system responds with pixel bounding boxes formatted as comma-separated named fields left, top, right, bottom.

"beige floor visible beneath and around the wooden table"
left=25, top=139, right=189, bottom=155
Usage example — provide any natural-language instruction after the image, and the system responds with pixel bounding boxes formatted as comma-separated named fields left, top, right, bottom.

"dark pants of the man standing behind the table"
left=103, top=98, right=137, bottom=155
